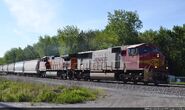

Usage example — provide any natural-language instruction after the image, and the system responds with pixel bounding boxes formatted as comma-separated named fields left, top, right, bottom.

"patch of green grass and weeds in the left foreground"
left=0, top=79, right=101, bottom=103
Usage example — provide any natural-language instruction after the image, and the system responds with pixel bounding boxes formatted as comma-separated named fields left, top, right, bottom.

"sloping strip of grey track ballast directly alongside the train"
left=0, top=75, right=185, bottom=97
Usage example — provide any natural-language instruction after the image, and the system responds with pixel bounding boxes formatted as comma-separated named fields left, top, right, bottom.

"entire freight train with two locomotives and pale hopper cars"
left=0, top=43, right=168, bottom=85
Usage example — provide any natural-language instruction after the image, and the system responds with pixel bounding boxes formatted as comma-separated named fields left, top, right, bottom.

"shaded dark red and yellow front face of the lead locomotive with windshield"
left=138, top=44, right=168, bottom=85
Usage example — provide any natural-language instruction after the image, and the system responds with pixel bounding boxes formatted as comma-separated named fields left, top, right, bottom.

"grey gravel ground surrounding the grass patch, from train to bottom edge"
left=0, top=75, right=185, bottom=107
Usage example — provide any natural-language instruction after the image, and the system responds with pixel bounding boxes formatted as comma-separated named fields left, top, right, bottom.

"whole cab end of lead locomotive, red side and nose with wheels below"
left=121, top=43, right=168, bottom=84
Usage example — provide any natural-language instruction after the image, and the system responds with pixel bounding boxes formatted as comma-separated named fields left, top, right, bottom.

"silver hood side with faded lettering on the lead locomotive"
left=91, top=47, right=124, bottom=71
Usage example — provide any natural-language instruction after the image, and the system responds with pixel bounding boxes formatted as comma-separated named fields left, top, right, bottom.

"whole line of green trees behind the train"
left=0, top=10, right=185, bottom=76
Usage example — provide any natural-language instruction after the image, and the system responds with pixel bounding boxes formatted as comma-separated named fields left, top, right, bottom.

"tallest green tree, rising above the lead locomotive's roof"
left=106, top=10, right=142, bottom=45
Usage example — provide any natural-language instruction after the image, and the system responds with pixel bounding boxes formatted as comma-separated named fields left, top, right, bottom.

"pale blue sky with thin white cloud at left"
left=0, top=0, right=185, bottom=57
